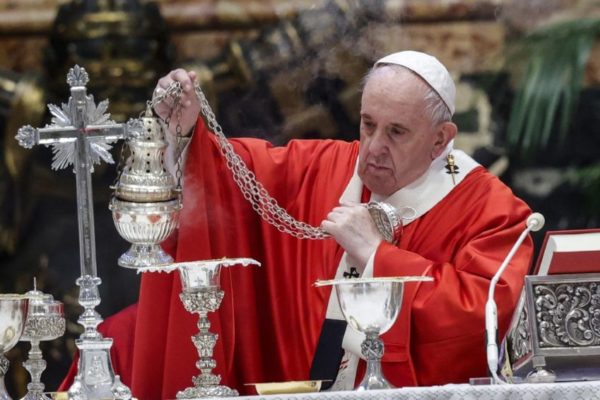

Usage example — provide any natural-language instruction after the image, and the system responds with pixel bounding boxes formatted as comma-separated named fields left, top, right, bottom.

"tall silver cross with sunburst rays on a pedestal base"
left=16, top=65, right=131, bottom=400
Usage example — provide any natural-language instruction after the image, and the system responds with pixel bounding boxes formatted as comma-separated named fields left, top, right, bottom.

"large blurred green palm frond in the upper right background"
left=507, top=18, right=600, bottom=158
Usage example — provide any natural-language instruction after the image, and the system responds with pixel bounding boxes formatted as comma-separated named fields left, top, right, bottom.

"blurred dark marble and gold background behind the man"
left=0, top=0, right=600, bottom=397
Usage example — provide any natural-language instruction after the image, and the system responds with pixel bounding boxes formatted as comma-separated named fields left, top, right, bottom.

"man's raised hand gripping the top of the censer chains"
left=154, top=68, right=200, bottom=136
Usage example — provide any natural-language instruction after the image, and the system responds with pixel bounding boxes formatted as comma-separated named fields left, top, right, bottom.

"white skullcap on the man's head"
left=375, top=50, right=456, bottom=115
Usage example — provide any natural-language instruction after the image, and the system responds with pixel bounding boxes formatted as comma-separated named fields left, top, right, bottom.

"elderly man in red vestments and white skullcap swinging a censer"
left=61, top=51, right=532, bottom=399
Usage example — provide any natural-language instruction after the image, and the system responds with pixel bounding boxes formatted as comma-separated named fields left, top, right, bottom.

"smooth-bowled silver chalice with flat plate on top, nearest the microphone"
left=315, top=276, right=433, bottom=390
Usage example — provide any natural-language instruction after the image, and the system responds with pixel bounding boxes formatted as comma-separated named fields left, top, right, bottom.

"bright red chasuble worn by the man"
left=63, top=120, right=532, bottom=400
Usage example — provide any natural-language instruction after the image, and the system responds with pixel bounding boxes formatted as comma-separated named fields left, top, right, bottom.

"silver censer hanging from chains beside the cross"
left=109, top=109, right=181, bottom=268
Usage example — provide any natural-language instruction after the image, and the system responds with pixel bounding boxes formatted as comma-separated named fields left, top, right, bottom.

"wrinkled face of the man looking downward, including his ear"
left=358, top=66, right=450, bottom=196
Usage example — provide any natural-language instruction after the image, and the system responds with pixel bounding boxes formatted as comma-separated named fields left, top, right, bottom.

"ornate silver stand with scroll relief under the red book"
left=506, top=273, right=600, bottom=381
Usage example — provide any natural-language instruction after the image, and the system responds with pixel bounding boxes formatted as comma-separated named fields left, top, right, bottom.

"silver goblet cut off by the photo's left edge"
left=0, top=294, right=27, bottom=400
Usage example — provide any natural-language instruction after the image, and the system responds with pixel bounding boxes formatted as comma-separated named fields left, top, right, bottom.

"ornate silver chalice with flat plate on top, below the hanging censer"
left=138, top=258, right=260, bottom=399
